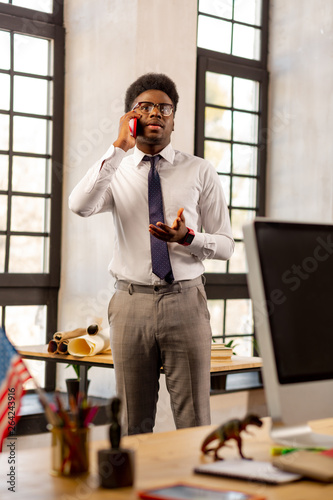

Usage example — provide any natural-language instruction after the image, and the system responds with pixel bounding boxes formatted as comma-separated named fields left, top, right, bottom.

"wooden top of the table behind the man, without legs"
left=17, top=345, right=262, bottom=373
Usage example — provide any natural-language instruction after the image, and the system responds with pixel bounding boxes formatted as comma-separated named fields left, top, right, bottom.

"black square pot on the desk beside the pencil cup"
left=98, top=448, right=135, bottom=488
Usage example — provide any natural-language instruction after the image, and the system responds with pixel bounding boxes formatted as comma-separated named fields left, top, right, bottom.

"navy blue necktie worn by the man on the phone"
left=143, top=155, right=174, bottom=283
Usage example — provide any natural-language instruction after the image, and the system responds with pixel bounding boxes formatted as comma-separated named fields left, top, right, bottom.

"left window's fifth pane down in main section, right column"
left=11, top=196, right=50, bottom=233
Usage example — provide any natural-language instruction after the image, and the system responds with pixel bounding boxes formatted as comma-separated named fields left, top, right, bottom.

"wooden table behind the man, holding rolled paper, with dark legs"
left=17, top=345, right=262, bottom=393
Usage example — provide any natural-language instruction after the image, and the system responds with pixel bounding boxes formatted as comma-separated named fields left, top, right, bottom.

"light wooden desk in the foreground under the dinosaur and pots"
left=0, top=418, right=333, bottom=500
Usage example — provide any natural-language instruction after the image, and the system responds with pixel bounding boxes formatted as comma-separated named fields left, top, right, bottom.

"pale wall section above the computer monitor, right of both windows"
left=267, top=0, right=333, bottom=222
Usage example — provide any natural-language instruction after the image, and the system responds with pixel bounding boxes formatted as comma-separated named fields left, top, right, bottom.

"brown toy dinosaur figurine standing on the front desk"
left=201, top=414, right=262, bottom=460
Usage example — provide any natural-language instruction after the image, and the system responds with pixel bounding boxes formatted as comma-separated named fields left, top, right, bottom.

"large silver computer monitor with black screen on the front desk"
left=243, top=218, right=333, bottom=447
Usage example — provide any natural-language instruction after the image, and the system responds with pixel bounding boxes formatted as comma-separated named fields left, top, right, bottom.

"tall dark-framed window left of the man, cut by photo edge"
left=0, top=0, right=64, bottom=389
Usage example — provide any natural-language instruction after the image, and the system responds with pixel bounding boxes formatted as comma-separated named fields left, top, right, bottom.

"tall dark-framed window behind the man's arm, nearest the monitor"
left=196, top=0, right=268, bottom=355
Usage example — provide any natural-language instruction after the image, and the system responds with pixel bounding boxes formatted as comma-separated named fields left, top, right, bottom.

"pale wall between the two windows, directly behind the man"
left=58, top=0, right=197, bottom=395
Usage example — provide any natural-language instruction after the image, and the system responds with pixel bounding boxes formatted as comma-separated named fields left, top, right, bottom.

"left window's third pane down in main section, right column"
left=13, top=116, right=49, bottom=154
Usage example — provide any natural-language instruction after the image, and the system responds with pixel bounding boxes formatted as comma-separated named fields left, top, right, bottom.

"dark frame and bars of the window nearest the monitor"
left=195, top=0, right=269, bottom=354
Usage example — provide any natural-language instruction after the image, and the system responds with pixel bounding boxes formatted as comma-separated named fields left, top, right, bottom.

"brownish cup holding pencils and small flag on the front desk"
left=51, top=427, right=90, bottom=476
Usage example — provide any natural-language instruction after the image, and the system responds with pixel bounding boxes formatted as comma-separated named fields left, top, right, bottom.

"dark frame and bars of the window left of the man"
left=0, top=0, right=65, bottom=391
